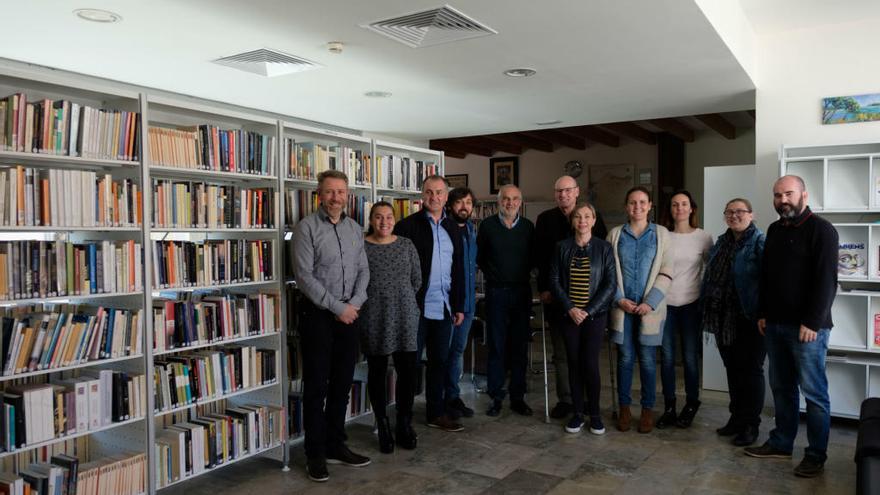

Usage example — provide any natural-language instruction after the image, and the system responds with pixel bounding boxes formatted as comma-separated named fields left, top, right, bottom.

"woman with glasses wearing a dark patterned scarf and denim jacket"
left=702, top=198, right=767, bottom=446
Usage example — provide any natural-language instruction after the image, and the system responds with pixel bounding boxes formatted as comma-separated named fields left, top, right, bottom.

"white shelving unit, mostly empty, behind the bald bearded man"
left=779, top=143, right=880, bottom=418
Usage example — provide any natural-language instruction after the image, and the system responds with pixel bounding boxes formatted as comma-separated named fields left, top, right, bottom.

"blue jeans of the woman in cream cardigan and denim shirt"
left=617, top=314, right=657, bottom=409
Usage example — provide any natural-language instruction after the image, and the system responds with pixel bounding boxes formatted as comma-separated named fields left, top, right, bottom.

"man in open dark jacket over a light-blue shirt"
left=394, top=175, right=464, bottom=431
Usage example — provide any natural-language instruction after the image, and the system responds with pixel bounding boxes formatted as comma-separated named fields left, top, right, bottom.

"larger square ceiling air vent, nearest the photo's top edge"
left=361, top=5, right=498, bottom=48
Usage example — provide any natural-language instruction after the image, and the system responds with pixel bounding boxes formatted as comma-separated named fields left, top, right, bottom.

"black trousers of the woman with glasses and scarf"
left=718, top=318, right=767, bottom=428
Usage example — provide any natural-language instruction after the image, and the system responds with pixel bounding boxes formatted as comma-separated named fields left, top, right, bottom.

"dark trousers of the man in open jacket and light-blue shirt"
left=418, top=311, right=452, bottom=421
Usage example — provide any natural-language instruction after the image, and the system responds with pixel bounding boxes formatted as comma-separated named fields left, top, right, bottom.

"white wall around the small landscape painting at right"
left=755, top=21, right=880, bottom=227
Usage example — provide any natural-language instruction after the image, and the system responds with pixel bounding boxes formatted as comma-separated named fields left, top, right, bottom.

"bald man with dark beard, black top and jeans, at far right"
left=745, top=175, right=838, bottom=478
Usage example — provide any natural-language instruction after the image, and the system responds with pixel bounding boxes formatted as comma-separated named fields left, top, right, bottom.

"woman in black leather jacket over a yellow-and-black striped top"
left=549, top=203, right=617, bottom=435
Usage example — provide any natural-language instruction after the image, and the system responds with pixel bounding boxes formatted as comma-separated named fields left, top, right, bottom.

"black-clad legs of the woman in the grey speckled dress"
left=367, top=351, right=417, bottom=419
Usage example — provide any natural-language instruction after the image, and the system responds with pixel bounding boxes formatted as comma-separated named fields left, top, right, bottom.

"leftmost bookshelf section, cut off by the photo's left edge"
left=0, top=69, right=147, bottom=493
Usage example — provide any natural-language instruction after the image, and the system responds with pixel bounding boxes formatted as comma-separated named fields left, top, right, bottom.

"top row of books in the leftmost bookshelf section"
left=0, top=93, right=141, bottom=161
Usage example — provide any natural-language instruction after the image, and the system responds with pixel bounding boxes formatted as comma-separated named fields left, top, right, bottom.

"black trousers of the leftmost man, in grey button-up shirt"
left=300, top=301, right=358, bottom=459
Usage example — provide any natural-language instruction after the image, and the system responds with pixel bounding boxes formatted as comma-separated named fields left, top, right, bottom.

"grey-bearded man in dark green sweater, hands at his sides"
left=477, top=184, right=535, bottom=416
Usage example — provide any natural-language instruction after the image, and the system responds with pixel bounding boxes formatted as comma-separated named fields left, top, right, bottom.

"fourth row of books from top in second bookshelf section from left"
left=153, top=294, right=280, bottom=352
